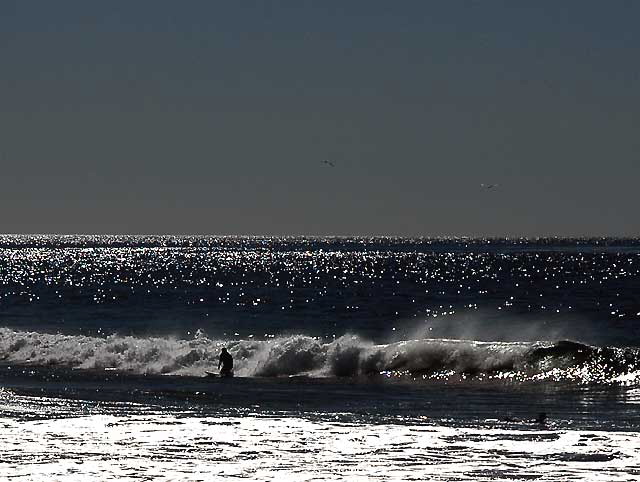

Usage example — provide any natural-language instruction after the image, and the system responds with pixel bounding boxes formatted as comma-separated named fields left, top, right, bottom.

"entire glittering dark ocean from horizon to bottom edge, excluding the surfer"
left=0, top=235, right=640, bottom=481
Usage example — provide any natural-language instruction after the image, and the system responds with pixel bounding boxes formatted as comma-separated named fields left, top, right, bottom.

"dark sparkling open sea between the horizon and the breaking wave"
left=0, top=236, right=640, bottom=346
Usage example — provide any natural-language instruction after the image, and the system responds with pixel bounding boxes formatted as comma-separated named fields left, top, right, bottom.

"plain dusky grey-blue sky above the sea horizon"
left=0, top=0, right=640, bottom=236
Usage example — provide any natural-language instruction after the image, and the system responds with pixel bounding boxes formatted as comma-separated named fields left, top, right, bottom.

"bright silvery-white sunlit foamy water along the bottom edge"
left=0, top=414, right=640, bottom=481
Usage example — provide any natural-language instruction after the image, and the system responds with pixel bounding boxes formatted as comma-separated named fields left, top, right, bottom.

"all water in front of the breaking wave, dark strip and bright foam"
left=0, top=378, right=640, bottom=481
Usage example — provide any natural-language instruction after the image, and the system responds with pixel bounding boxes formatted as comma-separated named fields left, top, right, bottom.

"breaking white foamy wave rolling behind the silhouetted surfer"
left=0, top=328, right=640, bottom=383
